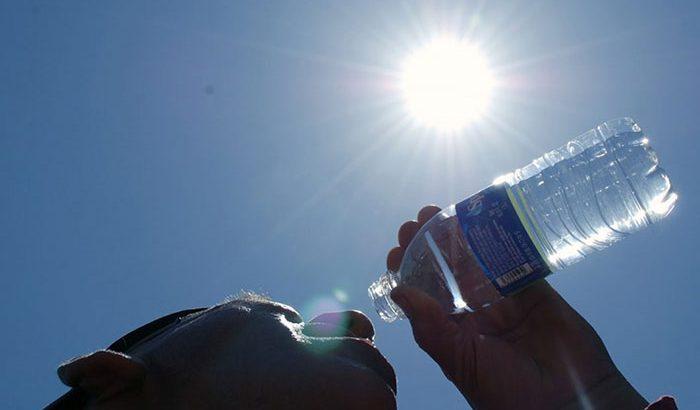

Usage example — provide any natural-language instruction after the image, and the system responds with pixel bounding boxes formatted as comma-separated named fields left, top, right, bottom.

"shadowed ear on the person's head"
left=58, top=350, right=146, bottom=399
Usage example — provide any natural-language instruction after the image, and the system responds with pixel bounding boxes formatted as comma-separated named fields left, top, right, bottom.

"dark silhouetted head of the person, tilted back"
left=47, top=294, right=396, bottom=409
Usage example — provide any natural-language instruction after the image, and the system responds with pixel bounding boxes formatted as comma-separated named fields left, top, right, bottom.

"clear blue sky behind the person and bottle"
left=0, top=0, right=700, bottom=409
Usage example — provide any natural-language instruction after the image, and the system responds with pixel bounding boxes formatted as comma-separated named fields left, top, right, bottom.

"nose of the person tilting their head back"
left=304, top=310, right=374, bottom=340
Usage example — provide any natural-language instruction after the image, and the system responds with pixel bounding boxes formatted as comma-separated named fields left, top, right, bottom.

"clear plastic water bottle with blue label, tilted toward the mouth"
left=369, top=118, right=678, bottom=322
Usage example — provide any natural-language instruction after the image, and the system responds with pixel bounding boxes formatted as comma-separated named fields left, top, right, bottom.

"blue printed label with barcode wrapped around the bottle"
left=456, top=184, right=551, bottom=296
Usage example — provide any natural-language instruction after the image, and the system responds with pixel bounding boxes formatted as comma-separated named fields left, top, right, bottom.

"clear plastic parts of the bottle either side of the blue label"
left=369, top=118, right=678, bottom=321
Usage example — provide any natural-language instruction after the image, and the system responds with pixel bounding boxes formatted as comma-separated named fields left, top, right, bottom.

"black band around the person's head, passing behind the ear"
left=44, top=308, right=207, bottom=410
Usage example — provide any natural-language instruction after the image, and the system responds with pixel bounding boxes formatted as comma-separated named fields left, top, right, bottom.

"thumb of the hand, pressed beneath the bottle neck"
left=391, top=285, right=464, bottom=368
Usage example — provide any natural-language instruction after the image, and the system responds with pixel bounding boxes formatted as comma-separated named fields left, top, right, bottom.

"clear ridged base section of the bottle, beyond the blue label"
left=512, top=119, right=678, bottom=269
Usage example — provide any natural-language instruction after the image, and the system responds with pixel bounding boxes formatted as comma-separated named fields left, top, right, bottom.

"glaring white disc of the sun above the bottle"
left=400, top=38, right=495, bottom=131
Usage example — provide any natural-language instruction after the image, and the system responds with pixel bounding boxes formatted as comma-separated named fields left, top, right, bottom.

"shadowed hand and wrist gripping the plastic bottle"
left=387, top=206, right=647, bottom=409
